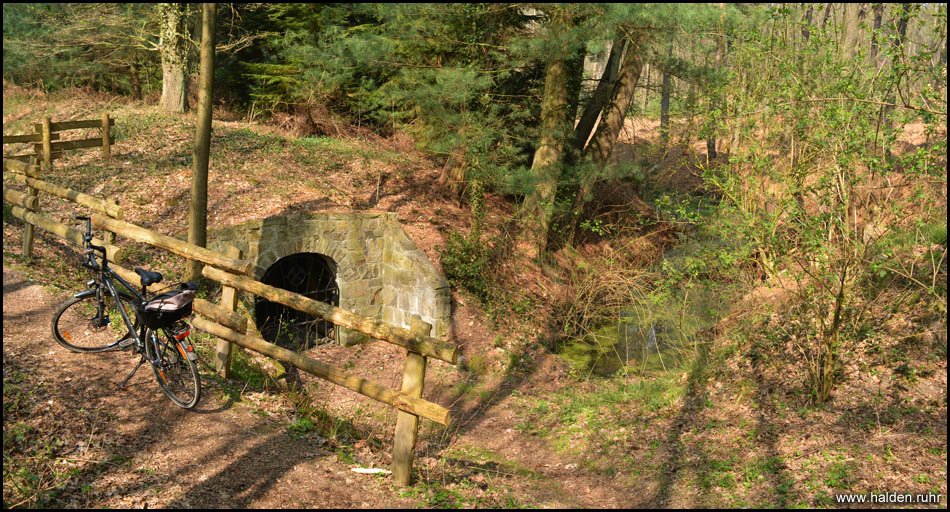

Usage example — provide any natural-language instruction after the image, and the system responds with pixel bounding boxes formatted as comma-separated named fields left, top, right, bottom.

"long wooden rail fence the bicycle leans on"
left=3, top=159, right=458, bottom=486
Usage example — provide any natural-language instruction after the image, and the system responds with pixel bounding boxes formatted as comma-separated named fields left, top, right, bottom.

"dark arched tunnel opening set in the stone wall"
left=254, top=252, right=340, bottom=351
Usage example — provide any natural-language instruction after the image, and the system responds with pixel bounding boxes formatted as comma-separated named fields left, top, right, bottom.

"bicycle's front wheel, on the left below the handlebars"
left=50, top=290, right=140, bottom=352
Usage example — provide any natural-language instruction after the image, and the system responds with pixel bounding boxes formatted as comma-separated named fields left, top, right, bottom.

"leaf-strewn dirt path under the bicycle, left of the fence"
left=3, top=269, right=411, bottom=508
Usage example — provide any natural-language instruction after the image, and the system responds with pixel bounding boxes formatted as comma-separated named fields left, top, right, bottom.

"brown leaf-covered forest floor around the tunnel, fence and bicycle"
left=3, top=83, right=947, bottom=508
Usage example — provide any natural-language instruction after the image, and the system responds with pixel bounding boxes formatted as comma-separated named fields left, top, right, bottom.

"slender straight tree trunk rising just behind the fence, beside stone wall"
left=185, top=3, right=216, bottom=279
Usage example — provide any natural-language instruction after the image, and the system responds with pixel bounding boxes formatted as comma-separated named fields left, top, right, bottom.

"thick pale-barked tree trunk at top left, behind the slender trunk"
left=159, top=3, right=188, bottom=113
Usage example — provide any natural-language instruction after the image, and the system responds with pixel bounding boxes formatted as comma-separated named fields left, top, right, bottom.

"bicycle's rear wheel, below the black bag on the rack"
left=145, top=329, right=201, bottom=409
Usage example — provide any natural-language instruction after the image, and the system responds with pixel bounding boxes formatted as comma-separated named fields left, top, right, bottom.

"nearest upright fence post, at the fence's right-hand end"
left=392, top=315, right=432, bottom=487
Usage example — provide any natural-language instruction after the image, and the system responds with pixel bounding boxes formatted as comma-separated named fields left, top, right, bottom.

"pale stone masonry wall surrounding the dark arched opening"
left=208, top=213, right=451, bottom=345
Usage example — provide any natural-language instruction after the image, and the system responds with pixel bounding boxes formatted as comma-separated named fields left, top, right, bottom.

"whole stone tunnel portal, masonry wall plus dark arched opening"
left=208, top=212, right=452, bottom=348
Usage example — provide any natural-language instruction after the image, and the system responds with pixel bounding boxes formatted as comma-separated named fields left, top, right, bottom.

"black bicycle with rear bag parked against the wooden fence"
left=50, top=216, right=201, bottom=409
